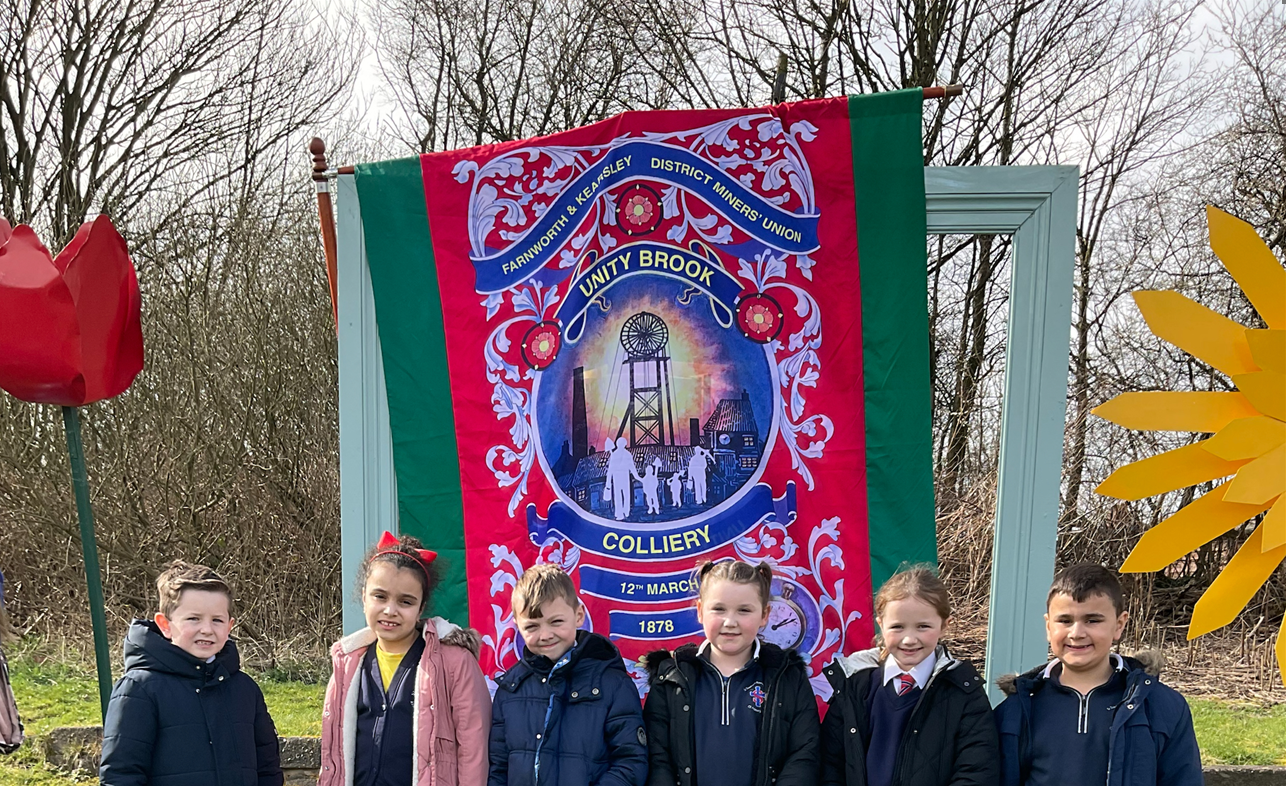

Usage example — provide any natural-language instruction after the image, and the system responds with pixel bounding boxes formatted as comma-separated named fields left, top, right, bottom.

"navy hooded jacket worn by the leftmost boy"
left=98, top=620, right=283, bottom=785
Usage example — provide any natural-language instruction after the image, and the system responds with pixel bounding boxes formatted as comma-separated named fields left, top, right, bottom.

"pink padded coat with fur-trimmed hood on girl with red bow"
left=318, top=618, right=491, bottom=785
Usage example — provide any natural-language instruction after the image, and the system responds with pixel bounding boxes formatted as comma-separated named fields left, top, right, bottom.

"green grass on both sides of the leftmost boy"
left=0, top=649, right=325, bottom=785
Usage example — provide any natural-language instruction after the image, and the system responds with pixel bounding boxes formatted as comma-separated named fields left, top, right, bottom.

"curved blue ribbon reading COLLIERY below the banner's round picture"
left=527, top=482, right=796, bottom=560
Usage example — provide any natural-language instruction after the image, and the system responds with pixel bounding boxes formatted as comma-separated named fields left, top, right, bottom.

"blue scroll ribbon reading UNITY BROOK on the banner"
left=556, top=242, right=742, bottom=345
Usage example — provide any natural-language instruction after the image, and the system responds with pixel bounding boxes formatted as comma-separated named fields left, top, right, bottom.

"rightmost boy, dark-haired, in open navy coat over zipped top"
left=995, top=563, right=1202, bottom=785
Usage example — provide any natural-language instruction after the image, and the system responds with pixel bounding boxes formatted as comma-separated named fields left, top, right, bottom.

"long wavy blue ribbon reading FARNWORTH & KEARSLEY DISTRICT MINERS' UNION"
left=471, top=140, right=818, bottom=293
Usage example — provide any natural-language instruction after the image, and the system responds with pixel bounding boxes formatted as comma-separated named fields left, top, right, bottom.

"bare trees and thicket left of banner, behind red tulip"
left=0, top=0, right=361, bottom=644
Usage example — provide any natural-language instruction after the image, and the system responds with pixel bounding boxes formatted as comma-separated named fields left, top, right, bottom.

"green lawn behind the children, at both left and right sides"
left=0, top=652, right=1286, bottom=785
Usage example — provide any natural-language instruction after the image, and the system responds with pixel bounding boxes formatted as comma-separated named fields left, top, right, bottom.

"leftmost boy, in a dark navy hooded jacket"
left=98, top=560, right=283, bottom=785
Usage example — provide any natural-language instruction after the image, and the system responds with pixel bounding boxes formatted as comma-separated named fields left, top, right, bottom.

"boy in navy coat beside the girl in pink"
left=487, top=564, right=647, bottom=785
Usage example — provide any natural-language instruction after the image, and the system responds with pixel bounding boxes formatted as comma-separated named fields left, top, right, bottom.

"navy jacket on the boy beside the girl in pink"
left=487, top=630, right=647, bottom=785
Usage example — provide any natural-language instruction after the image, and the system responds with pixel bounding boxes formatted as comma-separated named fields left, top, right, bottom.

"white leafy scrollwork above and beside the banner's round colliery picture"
left=451, top=113, right=835, bottom=517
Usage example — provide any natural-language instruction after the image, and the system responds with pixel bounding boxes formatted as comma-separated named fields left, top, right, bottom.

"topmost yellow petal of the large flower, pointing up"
left=1206, top=206, right=1286, bottom=328
